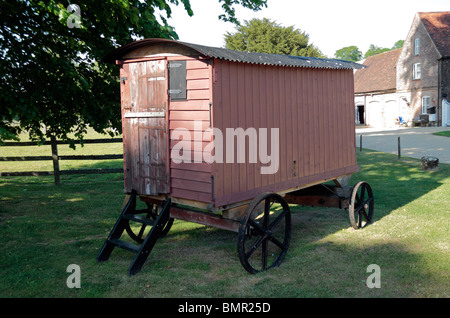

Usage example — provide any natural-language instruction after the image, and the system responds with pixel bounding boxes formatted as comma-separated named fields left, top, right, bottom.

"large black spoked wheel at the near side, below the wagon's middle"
left=238, top=193, right=291, bottom=274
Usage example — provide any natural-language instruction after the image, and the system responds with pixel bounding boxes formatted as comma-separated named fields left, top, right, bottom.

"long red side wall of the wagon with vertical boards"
left=213, top=60, right=357, bottom=206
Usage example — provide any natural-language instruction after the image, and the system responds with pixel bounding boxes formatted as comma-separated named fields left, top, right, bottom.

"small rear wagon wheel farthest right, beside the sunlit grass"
left=348, top=181, right=374, bottom=230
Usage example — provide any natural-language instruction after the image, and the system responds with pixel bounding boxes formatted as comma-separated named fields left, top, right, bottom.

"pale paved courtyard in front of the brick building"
left=356, top=127, right=450, bottom=164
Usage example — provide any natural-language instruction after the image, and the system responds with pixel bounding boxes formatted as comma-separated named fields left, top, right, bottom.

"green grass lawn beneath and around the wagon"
left=0, top=144, right=450, bottom=298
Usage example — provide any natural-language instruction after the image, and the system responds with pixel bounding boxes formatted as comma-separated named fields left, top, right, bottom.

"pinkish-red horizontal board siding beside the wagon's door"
left=169, top=59, right=212, bottom=203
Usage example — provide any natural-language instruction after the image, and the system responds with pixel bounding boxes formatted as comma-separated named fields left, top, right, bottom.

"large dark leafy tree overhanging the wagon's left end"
left=0, top=0, right=267, bottom=147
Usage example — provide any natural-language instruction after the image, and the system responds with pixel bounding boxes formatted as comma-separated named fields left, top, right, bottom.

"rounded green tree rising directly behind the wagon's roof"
left=225, top=18, right=323, bottom=57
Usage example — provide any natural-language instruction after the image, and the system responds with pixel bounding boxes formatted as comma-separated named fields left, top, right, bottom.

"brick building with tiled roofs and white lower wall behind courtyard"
left=355, top=12, right=450, bottom=127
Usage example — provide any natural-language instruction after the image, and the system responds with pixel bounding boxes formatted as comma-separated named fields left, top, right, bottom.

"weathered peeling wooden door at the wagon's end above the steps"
left=121, top=60, right=169, bottom=195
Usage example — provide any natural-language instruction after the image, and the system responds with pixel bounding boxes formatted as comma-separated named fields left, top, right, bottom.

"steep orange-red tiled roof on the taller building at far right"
left=418, top=11, right=450, bottom=57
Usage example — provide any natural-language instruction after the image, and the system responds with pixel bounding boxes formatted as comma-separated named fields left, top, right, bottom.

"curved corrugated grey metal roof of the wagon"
left=103, top=39, right=364, bottom=69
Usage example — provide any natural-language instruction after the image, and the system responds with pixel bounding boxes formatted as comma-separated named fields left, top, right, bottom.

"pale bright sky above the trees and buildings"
left=168, top=0, right=450, bottom=57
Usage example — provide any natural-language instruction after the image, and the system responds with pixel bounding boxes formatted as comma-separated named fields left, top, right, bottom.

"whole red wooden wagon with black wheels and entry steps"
left=97, top=39, right=374, bottom=275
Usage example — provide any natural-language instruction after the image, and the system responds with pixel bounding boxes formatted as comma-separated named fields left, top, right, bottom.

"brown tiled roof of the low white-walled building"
left=355, top=49, right=402, bottom=93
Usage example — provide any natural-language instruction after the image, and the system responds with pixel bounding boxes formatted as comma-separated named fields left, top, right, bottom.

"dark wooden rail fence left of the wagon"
left=0, top=138, right=123, bottom=185
